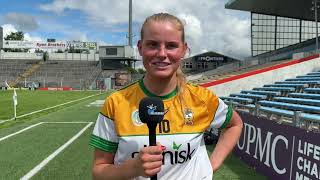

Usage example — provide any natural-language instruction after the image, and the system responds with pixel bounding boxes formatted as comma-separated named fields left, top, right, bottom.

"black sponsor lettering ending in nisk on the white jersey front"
left=131, top=142, right=195, bottom=165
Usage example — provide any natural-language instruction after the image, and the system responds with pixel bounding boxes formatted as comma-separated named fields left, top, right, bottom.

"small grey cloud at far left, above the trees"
left=3, top=12, right=39, bottom=31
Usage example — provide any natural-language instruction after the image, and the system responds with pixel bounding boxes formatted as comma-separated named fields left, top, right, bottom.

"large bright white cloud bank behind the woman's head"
left=40, top=0, right=250, bottom=58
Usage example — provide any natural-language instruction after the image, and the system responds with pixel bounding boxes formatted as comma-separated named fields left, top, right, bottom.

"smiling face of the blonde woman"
left=138, top=21, right=187, bottom=79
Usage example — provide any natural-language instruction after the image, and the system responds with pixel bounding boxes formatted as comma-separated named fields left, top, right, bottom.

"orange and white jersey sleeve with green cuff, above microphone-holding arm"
left=89, top=96, right=119, bottom=153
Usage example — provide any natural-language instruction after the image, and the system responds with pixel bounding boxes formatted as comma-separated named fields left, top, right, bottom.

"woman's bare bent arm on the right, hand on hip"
left=210, top=111, right=243, bottom=172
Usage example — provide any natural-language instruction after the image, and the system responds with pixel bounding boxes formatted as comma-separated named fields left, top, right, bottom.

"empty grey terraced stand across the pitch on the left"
left=0, top=59, right=101, bottom=89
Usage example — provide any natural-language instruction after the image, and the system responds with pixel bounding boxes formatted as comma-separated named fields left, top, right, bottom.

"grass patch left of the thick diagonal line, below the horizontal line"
left=0, top=124, right=84, bottom=179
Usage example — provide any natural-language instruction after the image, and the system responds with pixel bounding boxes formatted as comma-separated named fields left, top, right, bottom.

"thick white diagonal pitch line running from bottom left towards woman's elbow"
left=20, top=122, right=93, bottom=180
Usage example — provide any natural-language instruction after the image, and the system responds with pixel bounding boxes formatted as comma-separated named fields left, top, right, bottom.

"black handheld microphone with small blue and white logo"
left=139, top=97, right=165, bottom=180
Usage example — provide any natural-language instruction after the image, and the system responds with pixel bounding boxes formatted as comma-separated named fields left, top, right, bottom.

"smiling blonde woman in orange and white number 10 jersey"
left=90, top=13, right=243, bottom=180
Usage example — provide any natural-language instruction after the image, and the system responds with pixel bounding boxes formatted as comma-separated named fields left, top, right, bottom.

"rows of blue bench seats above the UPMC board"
left=220, top=71, right=320, bottom=131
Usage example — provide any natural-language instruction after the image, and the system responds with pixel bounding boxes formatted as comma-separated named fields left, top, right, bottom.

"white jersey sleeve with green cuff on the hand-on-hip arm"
left=210, top=98, right=233, bottom=129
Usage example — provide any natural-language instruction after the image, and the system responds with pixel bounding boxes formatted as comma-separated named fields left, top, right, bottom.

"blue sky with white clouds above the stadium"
left=0, top=0, right=251, bottom=59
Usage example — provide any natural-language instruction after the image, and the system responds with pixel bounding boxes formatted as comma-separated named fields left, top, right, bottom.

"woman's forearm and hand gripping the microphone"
left=92, top=145, right=162, bottom=180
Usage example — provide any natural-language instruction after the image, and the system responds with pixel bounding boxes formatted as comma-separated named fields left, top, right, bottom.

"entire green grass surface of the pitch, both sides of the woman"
left=0, top=91, right=266, bottom=180
